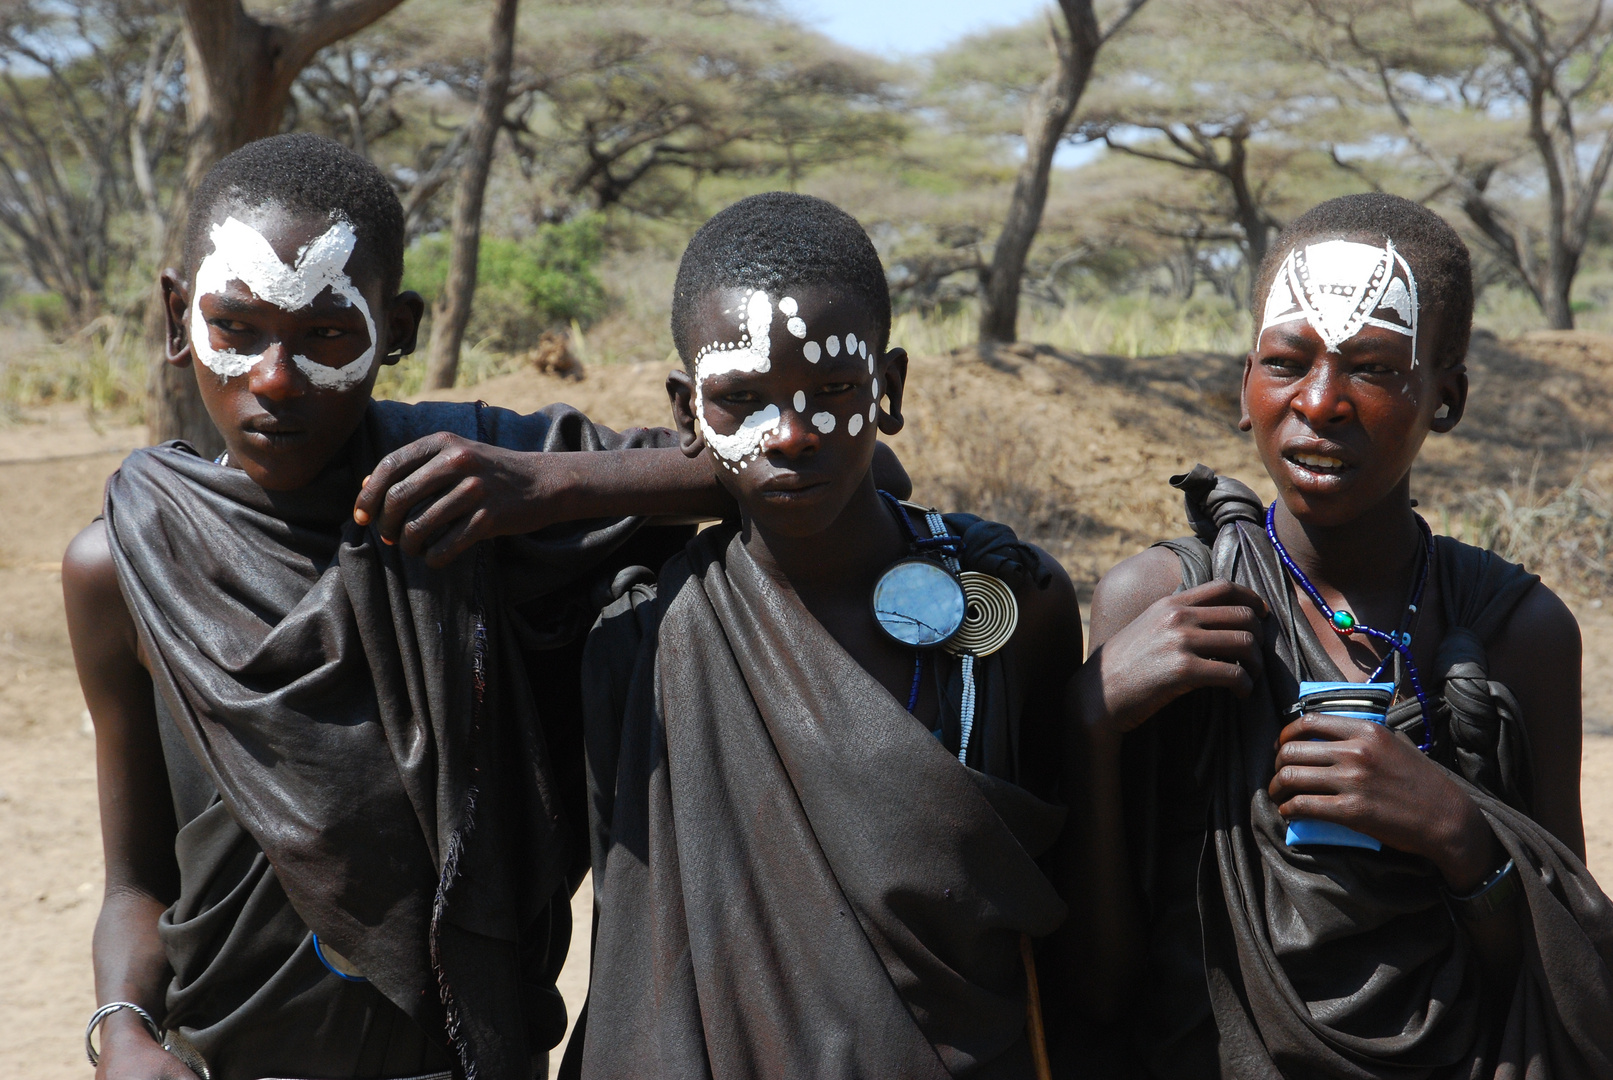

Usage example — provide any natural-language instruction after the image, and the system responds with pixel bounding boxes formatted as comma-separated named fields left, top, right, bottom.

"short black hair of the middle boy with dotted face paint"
left=673, top=192, right=890, bottom=364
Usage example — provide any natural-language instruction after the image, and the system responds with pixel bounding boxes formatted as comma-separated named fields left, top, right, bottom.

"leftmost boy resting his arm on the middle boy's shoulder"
left=63, top=135, right=761, bottom=1080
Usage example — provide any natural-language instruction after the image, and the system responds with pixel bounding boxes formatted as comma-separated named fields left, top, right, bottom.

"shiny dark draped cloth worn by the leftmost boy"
left=105, top=401, right=671, bottom=1080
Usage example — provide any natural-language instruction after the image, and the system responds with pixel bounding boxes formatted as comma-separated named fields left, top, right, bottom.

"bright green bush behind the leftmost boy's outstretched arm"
left=403, top=214, right=605, bottom=351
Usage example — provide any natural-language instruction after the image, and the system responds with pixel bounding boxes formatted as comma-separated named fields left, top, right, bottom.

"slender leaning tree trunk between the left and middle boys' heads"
left=426, top=0, right=519, bottom=390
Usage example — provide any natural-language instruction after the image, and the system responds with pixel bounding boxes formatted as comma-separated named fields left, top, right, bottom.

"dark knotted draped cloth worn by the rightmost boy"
left=1124, top=466, right=1613, bottom=1080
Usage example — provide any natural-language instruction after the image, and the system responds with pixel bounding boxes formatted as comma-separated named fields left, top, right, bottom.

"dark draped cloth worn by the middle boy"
left=568, top=519, right=1065, bottom=1080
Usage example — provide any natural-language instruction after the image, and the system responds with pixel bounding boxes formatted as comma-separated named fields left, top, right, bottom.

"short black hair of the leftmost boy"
left=185, top=132, right=403, bottom=300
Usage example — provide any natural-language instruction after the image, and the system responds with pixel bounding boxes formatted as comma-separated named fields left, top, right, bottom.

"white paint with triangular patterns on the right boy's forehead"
left=1260, top=240, right=1418, bottom=368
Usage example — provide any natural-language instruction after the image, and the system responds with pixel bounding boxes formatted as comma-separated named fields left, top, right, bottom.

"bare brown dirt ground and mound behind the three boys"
left=0, top=334, right=1613, bottom=1080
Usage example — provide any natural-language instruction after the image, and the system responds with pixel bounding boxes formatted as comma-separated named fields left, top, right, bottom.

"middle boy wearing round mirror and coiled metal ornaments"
left=561, top=193, right=1081, bottom=1080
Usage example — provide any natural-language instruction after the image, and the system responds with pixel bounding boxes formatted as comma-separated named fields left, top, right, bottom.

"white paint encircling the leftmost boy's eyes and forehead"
left=190, top=218, right=376, bottom=390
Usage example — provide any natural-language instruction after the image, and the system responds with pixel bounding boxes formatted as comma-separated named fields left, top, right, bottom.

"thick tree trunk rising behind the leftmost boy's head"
left=145, top=0, right=402, bottom=456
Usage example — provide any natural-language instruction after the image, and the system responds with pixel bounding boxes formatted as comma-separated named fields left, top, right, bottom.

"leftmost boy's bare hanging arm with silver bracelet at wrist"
left=61, top=522, right=195, bottom=1080
